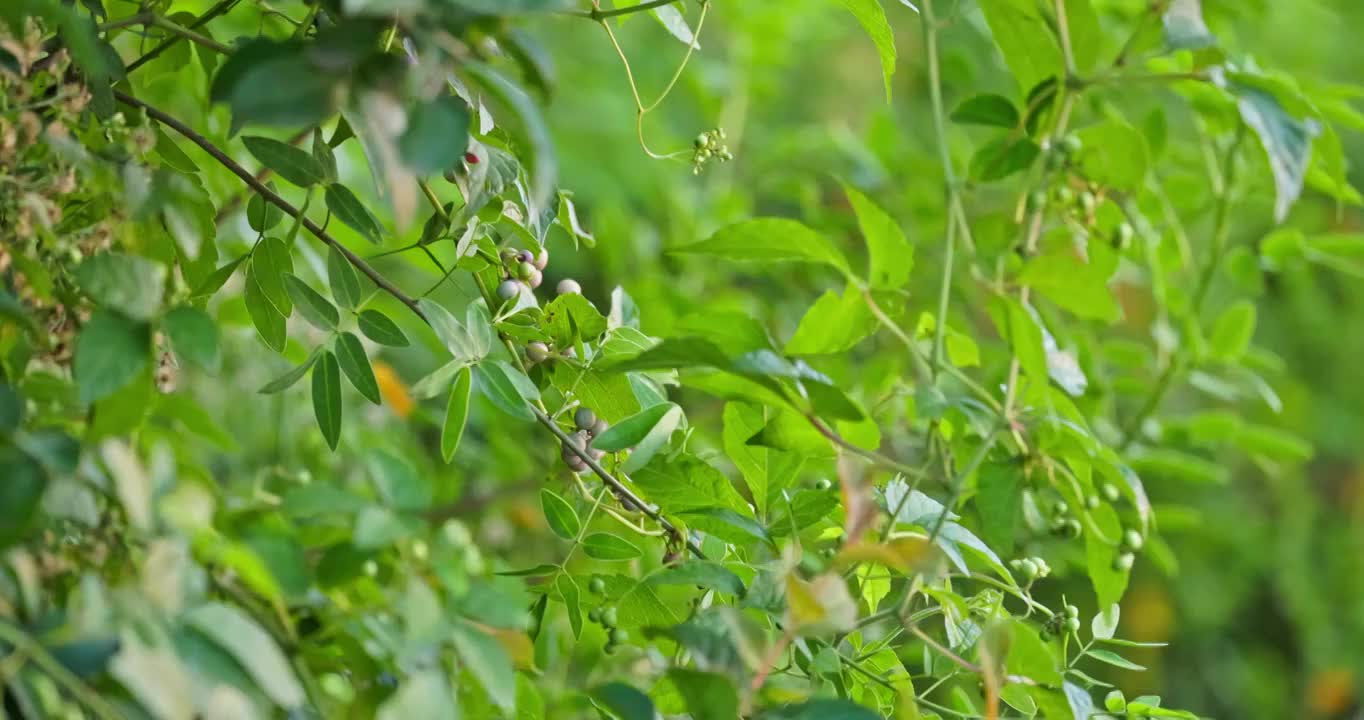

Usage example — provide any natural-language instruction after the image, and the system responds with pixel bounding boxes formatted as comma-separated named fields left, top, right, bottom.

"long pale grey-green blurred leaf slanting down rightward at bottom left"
left=184, top=603, right=307, bottom=708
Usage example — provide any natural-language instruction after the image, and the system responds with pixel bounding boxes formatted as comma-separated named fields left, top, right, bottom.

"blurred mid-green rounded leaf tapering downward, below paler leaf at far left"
left=74, top=310, right=151, bottom=405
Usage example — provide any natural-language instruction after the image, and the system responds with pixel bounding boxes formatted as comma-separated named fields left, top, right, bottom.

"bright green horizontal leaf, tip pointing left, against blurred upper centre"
left=672, top=218, right=853, bottom=275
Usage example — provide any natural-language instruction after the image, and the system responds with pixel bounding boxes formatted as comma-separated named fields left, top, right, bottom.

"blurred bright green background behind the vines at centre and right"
left=526, top=0, right=1364, bottom=719
